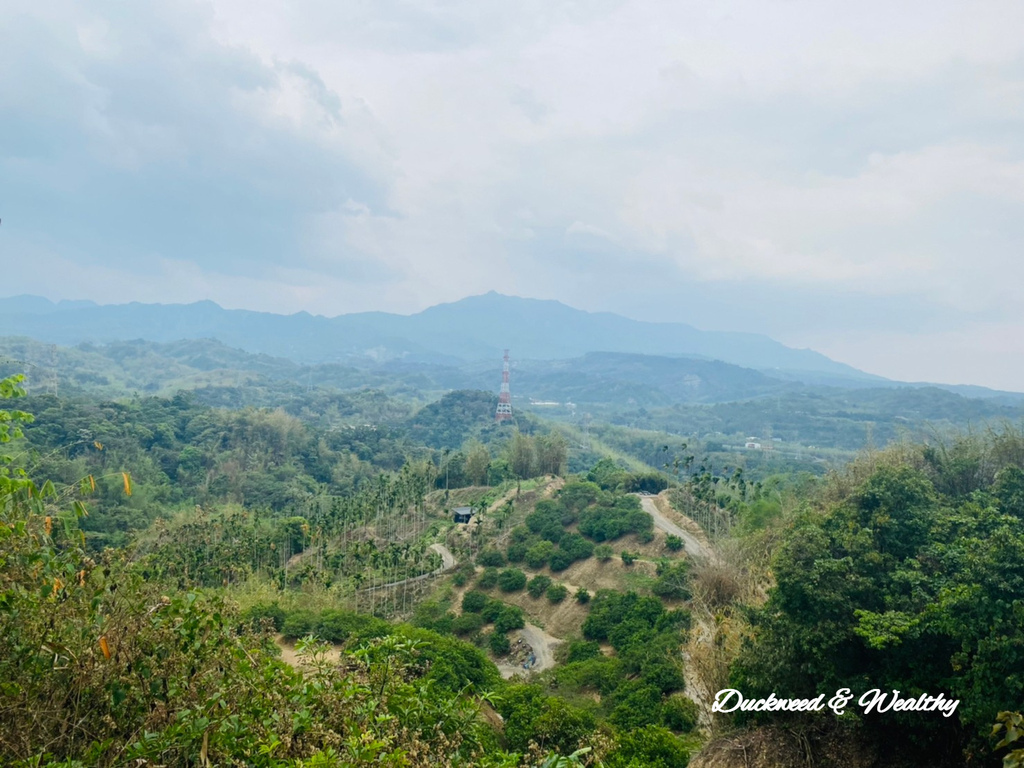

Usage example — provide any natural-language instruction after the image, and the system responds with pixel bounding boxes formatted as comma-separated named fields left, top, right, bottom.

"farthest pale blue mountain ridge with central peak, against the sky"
left=0, top=292, right=884, bottom=383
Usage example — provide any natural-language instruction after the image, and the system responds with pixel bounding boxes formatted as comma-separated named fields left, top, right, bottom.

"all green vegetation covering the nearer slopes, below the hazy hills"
left=0, top=352, right=1024, bottom=768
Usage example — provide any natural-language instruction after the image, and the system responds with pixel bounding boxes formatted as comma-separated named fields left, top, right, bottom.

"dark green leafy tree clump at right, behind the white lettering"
left=733, top=436, right=1024, bottom=765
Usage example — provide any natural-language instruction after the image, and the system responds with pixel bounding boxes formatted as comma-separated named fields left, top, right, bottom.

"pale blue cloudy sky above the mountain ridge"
left=0, top=0, right=1024, bottom=391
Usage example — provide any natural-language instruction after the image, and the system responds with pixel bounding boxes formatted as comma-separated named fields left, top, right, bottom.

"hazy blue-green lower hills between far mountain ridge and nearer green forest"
left=6, top=338, right=1024, bottom=465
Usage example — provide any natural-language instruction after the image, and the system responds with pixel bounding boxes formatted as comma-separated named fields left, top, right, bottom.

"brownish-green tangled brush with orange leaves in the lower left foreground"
left=0, top=381, right=593, bottom=767
